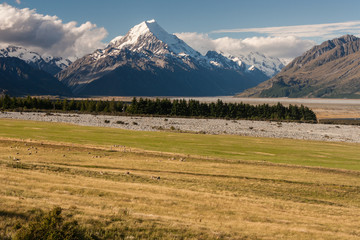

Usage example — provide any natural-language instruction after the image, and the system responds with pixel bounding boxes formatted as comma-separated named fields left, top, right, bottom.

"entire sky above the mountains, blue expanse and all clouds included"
left=0, top=0, right=360, bottom=58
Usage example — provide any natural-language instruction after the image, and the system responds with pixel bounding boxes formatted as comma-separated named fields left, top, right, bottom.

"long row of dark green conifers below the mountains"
left=0, top=95, right=316, bottom=121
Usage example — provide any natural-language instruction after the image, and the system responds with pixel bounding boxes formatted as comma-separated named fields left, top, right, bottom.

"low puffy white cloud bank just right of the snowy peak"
left=176, top=33, right=316, bottom=59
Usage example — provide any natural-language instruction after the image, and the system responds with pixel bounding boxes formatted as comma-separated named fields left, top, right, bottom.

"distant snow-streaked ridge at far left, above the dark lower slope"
left=0, top=46, right=71, bottom=75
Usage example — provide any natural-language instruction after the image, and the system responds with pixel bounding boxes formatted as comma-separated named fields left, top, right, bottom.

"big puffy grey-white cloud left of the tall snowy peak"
left=0, top=3, right=107, bottom=58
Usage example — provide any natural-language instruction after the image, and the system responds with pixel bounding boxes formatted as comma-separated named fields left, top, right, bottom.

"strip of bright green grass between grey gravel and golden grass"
left=0, top=120, right=360, bottom=170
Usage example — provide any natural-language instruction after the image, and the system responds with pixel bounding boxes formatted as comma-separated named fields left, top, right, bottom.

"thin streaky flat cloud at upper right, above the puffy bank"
left=211, top=21, right=360, bottom=39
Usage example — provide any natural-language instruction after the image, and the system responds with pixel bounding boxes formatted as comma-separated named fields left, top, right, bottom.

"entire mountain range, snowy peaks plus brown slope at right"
left=7, top=20, right=360, bottom=98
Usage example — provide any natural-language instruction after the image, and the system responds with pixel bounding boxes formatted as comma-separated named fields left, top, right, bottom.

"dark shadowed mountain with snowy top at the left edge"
left=0, top=46, right=72, bottom=96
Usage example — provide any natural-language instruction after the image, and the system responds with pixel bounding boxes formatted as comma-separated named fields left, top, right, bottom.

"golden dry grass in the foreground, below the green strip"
left=0, top=140, right=360, bottom=239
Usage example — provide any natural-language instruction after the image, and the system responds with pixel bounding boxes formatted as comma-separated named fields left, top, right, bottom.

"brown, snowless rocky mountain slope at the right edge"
left=238, top=35, right=360, bottom=98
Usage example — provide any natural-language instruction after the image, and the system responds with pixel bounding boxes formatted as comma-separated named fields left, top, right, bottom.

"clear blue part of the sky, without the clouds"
left=16, top=0, right=360, bottom=40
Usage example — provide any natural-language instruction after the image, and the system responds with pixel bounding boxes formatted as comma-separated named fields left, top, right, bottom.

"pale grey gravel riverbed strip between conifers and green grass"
left=0, top=112, right=360, bottom=143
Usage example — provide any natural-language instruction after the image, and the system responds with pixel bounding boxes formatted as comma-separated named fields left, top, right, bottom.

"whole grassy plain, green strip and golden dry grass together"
left=0, top=120, right=360, bottom=239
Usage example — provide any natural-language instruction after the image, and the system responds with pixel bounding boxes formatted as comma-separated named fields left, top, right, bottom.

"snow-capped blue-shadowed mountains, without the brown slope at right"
left=0, top=20, right=284, bottom=96
